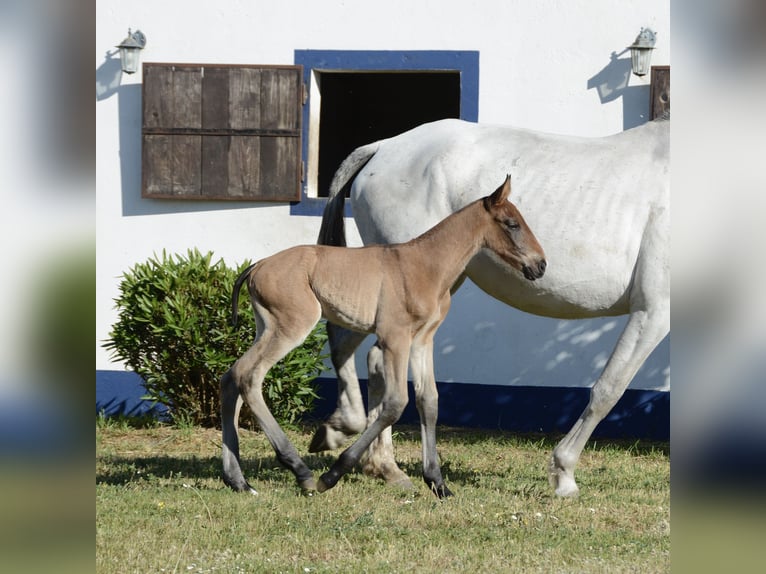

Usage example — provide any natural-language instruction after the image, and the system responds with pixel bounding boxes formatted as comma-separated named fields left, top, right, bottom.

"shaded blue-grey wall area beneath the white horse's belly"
left=436, top=281, right=670, bottom=390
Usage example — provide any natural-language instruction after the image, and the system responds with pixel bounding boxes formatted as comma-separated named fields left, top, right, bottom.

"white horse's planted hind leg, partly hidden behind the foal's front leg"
left=362, top=342, right=413, bottom=488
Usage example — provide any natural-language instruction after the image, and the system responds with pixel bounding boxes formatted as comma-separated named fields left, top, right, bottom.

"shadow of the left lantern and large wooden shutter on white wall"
left=96, top=50, right=272, bottom=217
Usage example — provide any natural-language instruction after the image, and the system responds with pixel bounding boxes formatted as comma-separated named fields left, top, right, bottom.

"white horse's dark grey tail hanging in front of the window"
left=317, top=140, right=382, bottom=246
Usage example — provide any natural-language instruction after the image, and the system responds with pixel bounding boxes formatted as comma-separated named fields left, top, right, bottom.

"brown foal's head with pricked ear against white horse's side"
left=484, top=175, right=547, bottom=281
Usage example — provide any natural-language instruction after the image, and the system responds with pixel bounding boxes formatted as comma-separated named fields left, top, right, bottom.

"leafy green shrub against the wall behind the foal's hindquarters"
left=104, top=249, right=327, bottom=426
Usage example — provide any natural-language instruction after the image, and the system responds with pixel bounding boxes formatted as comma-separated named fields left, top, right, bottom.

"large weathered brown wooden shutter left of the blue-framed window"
left=141, top=63, right=303, bottom=201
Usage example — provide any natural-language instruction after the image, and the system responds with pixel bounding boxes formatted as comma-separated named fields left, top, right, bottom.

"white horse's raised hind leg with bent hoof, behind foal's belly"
left=309, top=323, right=367, bottom=452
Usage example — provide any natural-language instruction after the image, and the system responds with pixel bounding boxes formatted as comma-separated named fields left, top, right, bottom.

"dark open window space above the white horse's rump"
left=317, top=71, right=460, bottom=197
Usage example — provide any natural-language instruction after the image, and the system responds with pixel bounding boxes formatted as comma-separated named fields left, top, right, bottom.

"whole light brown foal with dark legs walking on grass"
left=221, top=176, right=546, bottom=497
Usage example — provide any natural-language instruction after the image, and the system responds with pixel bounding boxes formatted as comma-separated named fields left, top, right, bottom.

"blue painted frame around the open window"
left=290, top=50, right=479, bottom=216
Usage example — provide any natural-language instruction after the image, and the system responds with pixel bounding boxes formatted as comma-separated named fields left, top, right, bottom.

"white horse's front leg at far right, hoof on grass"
left=548, top=211, right=670, bottom=496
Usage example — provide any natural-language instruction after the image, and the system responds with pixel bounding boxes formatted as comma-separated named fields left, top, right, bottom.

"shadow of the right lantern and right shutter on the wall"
left=588, top=48, right=651, bottom=130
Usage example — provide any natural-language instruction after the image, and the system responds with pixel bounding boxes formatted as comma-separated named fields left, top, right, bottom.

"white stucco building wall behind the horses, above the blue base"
left=96, top=0, right=670, bottom=389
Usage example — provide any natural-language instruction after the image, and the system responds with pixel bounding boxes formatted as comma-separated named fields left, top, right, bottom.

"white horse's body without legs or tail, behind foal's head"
left=351, top=120, right=669, bottom=318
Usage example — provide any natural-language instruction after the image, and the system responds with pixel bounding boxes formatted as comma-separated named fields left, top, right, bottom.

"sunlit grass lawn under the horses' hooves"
left=96, top=421, right=670, bottom=574
